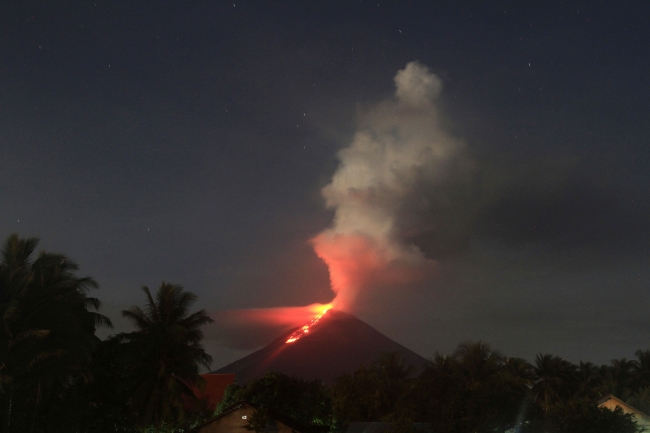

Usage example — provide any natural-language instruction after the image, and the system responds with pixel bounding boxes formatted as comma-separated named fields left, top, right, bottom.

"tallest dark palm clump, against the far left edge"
left=0, top=234, right=112, bottom=431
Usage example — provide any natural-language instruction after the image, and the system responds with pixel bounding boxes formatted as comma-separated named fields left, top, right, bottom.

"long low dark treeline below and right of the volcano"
left=217, top=348, right=650, bottom=433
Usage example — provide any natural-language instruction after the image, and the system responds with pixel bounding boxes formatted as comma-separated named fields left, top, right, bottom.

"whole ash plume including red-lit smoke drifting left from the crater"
left=212, top=62, right=471, bottom=348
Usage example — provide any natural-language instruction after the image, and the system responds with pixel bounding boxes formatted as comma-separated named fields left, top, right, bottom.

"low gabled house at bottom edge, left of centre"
left=190, top=401, right=313, bottom=433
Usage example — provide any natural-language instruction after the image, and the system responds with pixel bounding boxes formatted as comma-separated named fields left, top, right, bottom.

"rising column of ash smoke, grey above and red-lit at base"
left=311, top=62, right=461, bottom=310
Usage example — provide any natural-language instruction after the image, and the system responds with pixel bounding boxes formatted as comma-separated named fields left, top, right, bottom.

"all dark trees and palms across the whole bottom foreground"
left=0, top=235, right=650, bottom=433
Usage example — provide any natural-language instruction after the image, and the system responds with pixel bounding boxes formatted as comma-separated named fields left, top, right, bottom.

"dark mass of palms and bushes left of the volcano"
left=0, top=235, right=211, bottom=433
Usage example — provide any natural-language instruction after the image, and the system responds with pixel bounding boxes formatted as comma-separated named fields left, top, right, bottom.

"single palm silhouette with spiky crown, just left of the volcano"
left=120, top=282, right=212, bottom=431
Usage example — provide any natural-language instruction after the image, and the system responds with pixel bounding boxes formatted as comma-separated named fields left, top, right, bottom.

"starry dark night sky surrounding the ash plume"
left=0, top=0, right=650, bottom=368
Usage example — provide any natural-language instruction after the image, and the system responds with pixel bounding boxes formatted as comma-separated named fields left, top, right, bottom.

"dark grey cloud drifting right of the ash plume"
left=400, top=148, right=650, bottom=260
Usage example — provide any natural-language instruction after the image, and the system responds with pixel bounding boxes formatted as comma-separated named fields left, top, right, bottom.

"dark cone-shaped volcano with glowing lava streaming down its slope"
left=212, top=310, right=426, bottom=384
